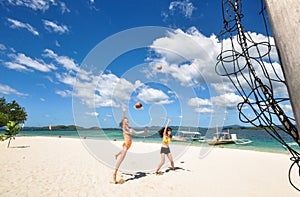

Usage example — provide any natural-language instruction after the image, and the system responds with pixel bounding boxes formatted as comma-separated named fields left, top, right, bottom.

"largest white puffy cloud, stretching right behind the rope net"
left=150, top=27, right=287, bottom=101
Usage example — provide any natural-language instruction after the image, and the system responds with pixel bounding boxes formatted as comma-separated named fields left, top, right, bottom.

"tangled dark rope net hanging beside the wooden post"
left=215, top=0, right=300, bottom=191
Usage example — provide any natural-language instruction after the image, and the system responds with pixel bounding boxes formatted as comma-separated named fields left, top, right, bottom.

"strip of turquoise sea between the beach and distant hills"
left=6, top=129, right=300, bottom=153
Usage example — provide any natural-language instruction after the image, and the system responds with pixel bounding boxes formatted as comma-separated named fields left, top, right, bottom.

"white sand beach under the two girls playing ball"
left=0, top=137, right=300, bottom=197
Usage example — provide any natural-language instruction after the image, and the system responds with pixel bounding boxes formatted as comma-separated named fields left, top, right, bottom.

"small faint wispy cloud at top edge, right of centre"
left=169, top=0, right=195, bottom=18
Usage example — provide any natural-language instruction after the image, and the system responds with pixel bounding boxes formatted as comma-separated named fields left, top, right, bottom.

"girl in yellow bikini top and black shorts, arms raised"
left=155, top=118, right=175, bottom=175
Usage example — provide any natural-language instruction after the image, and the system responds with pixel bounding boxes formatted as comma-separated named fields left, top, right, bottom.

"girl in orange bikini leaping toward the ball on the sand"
left=113, top=107, right=148, bottom=183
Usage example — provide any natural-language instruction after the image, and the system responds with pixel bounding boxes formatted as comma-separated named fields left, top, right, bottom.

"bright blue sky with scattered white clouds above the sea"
left=0, top=0, right=291, bottom=128
